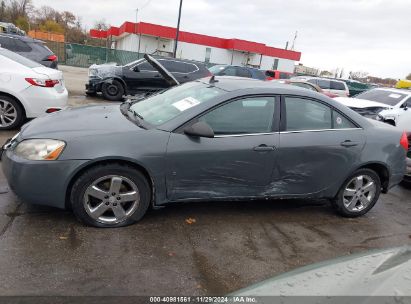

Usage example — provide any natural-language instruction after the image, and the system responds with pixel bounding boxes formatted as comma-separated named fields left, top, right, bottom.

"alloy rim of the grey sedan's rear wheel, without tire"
left=343, top=175, right=377, bottom=212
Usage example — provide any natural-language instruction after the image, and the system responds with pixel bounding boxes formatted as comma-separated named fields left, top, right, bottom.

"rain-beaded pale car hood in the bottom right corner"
left=233, top=246, right=411, bottom=296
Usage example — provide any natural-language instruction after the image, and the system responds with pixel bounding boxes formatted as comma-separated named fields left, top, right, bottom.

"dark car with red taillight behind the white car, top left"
left=0, top=34, right=58, bottom=69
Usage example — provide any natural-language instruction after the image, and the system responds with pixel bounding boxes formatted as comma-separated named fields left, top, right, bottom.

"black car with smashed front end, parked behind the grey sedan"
left=86, top=57, right=211, bottom=101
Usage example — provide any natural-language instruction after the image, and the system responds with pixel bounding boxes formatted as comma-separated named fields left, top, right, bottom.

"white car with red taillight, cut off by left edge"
left=0, top=47, right=68, bottom=130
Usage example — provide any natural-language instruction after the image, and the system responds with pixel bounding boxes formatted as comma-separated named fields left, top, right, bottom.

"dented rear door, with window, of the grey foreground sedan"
left=278, top=96, right=365, bottom=196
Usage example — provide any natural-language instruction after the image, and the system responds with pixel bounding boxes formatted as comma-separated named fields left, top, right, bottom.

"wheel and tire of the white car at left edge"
left=0, top=94, right=25, bottom=130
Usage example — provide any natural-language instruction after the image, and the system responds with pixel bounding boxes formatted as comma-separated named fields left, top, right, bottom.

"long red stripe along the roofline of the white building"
left=90, top=22, right=301, bottom=61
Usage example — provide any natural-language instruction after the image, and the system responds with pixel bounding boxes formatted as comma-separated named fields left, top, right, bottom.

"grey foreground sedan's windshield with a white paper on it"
left=130, top=81, right=225, bottom=126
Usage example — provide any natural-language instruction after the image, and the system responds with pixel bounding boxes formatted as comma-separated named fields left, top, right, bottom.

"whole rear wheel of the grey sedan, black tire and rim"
left=332, top=169, right=381, bottom=217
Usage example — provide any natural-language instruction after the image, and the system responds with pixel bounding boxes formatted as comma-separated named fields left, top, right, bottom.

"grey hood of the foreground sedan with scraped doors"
left=19, top=104, right=145, bottom=140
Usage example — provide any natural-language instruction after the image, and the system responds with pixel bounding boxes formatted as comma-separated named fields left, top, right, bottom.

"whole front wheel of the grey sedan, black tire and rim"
left=70, top=163, right=151, bottom=228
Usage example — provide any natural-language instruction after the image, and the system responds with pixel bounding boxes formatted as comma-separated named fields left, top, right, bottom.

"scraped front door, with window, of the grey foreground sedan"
left=167, top=96, right=279, bottom=201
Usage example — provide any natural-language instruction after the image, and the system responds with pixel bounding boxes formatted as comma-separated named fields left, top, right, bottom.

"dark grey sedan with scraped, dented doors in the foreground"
left=2, top=76, right=408, bottom=227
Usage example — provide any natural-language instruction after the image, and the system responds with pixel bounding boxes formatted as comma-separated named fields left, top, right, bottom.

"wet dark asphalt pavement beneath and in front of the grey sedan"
left=0, top=66, right=411, bottom=295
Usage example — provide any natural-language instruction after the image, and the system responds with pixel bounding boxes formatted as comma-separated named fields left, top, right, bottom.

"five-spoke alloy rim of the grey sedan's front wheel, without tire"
left=83, top=175, right=140, bottom=224
